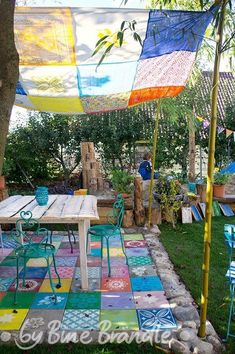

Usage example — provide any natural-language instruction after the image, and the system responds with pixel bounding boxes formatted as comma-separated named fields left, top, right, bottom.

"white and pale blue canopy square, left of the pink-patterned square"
left=77, top=62, right=137, bottom=97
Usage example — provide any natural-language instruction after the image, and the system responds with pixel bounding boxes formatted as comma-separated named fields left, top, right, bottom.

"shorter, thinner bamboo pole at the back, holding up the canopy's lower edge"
left=148, top=100, right=161, bottom=228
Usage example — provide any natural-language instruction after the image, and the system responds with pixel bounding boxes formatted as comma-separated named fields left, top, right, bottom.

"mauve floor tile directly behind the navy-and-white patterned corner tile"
left=134, top=291, right=170, bottom=309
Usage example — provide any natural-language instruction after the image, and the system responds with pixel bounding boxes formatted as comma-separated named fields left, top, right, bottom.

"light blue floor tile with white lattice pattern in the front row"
left=61, top=310, right=100, bottom=330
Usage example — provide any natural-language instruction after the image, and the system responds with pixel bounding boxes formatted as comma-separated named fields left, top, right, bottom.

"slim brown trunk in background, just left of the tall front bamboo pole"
left=188, top=116, right=196, bottom=182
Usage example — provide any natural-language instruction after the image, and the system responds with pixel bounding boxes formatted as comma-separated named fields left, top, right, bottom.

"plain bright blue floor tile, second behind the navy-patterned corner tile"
left=131, top=276, right=163, bottom=291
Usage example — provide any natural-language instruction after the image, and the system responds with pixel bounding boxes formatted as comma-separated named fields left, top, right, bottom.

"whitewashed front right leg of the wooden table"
left=78, top=220, right=88, bottom=290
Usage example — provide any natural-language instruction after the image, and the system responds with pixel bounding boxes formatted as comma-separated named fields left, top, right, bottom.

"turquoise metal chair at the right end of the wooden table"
left=87, top=194, right=127, bottom=277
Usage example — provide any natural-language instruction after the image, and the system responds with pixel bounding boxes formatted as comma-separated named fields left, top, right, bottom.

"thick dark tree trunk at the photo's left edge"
left=0, top=0, right=19, bottom=175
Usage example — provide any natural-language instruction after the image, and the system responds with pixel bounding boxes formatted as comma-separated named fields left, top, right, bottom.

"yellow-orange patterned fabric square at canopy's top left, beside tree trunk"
left=15, top=7, right=76, bottom=65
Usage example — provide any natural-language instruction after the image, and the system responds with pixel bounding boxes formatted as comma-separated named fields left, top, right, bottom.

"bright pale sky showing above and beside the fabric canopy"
left=10, top=0, right=235, bottom=128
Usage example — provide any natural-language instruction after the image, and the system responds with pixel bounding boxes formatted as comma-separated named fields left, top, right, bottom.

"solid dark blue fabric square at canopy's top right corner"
left=140, top=7, right=218, bottom=59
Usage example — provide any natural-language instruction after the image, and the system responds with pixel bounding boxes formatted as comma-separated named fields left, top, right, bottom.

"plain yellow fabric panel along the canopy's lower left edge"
left=28, top=96, right=84, bottom=114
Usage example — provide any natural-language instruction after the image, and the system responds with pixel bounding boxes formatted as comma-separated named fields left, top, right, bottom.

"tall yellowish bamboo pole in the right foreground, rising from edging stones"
left=199, top=0, right=227, bottom=337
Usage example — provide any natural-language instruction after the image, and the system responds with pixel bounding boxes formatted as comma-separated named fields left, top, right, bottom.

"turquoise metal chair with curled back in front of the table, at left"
left=11, top=211, right=61, bottom=305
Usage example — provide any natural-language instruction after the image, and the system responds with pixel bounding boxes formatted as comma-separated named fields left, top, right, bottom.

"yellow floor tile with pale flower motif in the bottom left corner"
left=0, top=309, right=29, bottom=331
